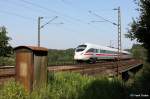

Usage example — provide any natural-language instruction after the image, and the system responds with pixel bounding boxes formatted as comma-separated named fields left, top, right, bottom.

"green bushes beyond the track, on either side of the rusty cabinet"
left=0, top=48, right=74, bottom=66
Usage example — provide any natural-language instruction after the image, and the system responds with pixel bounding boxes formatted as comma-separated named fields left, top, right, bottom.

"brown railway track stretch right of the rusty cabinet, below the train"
left=48, top=59, right=142, bottom=75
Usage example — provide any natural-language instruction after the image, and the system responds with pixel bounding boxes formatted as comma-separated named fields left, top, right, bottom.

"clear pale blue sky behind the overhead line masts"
left=0, top=0, right=138, bottom=49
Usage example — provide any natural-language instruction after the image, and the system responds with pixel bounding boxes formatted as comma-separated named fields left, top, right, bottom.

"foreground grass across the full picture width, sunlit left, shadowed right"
left=0, top=63, right=150, bottom=99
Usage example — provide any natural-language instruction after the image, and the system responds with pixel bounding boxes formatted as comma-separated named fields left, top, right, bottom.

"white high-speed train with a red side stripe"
left=74, top=43, right=132, bottom=63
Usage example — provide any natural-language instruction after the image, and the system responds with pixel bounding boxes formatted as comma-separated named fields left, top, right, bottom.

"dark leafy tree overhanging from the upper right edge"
left=126, top=0, right=150, bottom=62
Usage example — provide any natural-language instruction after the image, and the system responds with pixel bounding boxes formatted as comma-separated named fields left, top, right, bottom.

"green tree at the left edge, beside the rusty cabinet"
left=0, top=26, right=12, bottom=57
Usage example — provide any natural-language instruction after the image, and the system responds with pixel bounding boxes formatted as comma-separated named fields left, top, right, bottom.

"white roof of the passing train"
left=83, top=43, right=130, bottom=54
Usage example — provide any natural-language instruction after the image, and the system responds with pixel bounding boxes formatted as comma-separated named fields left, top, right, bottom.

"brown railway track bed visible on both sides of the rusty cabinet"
left=0, top=59, right=142, bottom=84
